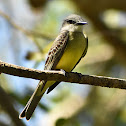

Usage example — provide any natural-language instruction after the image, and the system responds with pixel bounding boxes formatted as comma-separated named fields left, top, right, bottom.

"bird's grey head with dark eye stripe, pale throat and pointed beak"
left=61, top=14, right=87, bottom=32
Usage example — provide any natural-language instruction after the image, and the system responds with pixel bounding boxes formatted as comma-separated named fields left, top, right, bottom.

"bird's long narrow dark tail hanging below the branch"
left=19, top=81, right=46, bottom=120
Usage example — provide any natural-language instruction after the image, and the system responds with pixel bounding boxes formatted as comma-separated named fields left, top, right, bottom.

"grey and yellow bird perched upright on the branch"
left=19, top=14, right=88, bottom=120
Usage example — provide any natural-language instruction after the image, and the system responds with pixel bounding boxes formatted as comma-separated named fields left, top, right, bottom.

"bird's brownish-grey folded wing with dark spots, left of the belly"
left=44, top=31, right=69, bottom=70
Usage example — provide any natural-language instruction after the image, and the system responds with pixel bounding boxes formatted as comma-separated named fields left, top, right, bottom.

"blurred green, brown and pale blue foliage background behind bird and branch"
left=0, top=0, right=126, bottom=126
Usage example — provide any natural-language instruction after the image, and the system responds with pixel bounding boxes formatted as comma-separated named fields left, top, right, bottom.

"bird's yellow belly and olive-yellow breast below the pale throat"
left=56, top=33, right=86, bottom=72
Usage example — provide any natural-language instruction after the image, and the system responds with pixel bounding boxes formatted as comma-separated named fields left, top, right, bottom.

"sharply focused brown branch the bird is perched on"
left=0, top=61, right=126, bottom=89
